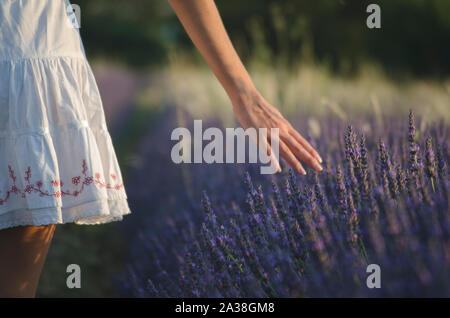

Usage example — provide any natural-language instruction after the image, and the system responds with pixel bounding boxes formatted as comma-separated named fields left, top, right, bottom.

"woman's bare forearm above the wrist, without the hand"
left=169, top=0, right=256, bottom=100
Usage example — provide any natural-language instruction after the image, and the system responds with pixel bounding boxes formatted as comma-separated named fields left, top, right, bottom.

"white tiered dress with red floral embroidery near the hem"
left=0, top=0, right=130, bottom=229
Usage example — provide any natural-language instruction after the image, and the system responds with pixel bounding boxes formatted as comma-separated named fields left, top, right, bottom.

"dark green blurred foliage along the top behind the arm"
left=73, top=0, right=450, bottom=76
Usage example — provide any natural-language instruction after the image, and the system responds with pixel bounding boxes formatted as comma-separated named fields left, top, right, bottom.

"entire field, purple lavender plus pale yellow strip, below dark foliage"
left=38, top=57, right=450, bottom=297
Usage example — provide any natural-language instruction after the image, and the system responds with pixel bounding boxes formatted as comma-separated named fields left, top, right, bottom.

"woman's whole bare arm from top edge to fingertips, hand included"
left=169, top=0, right=322, bottom=174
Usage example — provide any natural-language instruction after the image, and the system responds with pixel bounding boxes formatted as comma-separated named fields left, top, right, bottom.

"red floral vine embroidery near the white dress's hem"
left=0, top=160, right=123, bottom=205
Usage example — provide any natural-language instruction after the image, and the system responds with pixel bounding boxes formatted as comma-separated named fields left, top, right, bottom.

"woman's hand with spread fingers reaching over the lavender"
left=232, top=91, right=323, bottom=175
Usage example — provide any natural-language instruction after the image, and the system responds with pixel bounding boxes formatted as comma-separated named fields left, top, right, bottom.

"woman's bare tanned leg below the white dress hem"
left=0, top=224, right=55, bottom=298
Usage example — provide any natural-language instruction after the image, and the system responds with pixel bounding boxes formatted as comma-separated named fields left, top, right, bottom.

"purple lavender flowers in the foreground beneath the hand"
left=121, top=107, right=450, bottom=297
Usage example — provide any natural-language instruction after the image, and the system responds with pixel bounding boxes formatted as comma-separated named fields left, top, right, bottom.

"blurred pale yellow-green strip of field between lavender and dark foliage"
left=152, top=54, right=450, bottom=124
